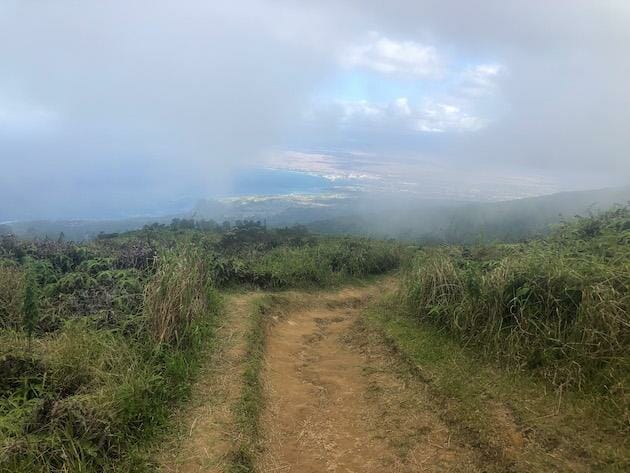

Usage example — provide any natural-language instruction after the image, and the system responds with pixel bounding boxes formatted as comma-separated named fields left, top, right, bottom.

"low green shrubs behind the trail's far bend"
left=139, top=220, right=403, bottom=289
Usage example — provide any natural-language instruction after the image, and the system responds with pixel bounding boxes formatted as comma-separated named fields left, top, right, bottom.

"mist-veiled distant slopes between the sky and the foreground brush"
left=6, top=188, right=630, bottom=243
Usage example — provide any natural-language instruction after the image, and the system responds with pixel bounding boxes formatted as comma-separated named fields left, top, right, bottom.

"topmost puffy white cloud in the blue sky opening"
left=340, top=32, right=443, bottom=78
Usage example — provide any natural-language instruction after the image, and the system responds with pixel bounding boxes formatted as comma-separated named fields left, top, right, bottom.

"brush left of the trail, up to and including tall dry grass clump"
left=0, top=240, right=218, bottom=471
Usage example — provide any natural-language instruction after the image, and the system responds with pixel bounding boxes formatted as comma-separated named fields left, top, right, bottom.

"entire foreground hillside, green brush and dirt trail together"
left=0, top=207, right=630, bottom=473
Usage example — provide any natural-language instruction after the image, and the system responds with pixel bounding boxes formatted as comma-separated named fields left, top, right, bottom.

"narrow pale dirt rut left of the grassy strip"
left=159, top=293, right=257, bottom=473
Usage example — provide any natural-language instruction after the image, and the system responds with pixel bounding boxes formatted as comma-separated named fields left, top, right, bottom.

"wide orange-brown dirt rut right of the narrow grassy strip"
left=258, top=286, right=481, bottom=473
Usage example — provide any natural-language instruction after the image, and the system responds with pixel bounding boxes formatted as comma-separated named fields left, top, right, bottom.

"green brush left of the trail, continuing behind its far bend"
left=0, top=219, right=401, bottom=472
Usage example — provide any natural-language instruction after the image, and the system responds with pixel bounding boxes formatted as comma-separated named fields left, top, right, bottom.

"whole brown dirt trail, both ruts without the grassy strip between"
left=159, top=279, right=612, bottom=473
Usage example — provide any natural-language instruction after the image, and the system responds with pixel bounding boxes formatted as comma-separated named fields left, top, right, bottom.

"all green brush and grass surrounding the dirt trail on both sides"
left=0, top=207, right=630, bottom=472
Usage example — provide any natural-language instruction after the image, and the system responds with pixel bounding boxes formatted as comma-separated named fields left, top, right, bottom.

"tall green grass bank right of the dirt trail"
left=401, top=208, right=630, bottom=406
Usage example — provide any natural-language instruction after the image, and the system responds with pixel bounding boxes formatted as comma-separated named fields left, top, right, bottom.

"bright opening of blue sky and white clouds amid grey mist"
left=306, top=27, right=506, bottom=144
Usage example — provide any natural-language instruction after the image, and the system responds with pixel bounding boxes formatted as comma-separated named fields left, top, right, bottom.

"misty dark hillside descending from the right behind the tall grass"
left=307, top=187, right=630, bottom=243
